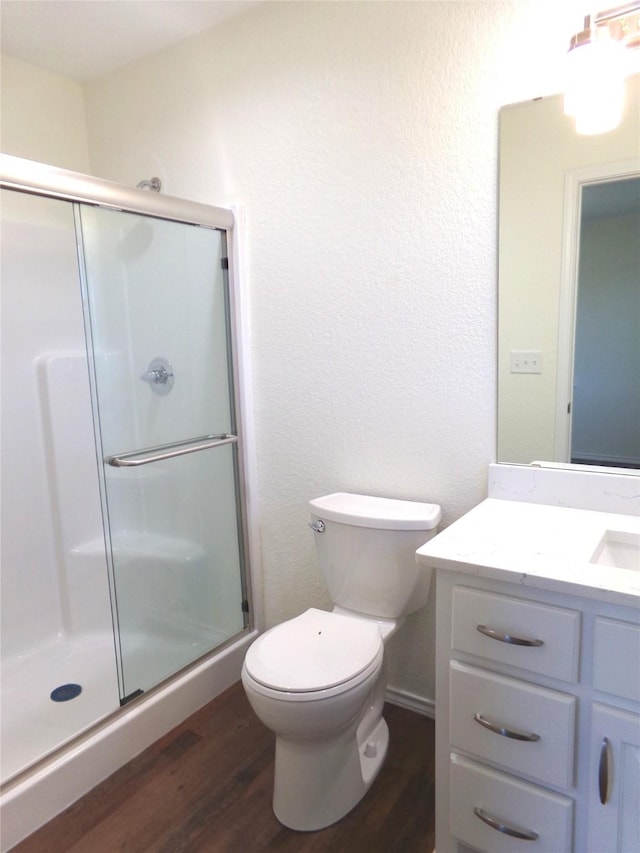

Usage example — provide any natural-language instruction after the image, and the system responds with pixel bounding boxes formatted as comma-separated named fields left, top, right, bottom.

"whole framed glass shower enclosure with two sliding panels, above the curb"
left=0, top=155, right=251, bottom=780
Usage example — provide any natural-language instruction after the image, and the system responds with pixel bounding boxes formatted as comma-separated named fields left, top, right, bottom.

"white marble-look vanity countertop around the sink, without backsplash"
left=416, top=498, right=640, bottom=607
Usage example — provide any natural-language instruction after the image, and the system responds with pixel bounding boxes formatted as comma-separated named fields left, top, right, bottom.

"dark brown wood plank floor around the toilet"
left=14, top=682, right=434, bottom=853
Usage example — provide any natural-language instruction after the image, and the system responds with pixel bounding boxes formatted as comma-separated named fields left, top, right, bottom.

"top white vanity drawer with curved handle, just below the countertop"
left=451, top=586, right=580, bottom=684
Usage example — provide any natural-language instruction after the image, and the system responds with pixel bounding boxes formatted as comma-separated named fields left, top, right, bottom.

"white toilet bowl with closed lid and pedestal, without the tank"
left=242, top=609, right=389, bottom=831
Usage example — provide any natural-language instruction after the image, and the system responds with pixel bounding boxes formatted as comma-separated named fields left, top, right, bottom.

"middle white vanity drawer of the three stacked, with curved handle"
left=449, top=661, right=577, bottom=788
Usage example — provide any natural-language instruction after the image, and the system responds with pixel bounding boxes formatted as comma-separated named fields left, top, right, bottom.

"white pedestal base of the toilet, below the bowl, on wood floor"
left=273, top=717, right=389, bottom=832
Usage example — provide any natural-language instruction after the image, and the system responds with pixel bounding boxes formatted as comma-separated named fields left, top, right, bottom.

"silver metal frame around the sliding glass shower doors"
left=0, top=154, right=255, bottom=681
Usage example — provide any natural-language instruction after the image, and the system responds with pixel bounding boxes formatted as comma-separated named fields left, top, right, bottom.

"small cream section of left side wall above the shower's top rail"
left=0, top=55, right=89, bottom=172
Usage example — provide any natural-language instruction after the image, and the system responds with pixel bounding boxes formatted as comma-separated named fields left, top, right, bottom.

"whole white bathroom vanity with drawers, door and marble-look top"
left=418, top=501, right=640, bottom=853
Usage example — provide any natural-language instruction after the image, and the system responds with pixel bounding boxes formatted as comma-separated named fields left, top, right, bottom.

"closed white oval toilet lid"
left=245, top=608, right=382, bottom=692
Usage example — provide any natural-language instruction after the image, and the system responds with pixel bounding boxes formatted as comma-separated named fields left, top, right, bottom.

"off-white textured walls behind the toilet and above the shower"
left=2, top=0, right=636, bottom=848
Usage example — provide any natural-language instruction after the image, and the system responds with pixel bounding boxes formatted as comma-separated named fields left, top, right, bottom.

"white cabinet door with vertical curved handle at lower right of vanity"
left=588, top=704, right=640, bottom=853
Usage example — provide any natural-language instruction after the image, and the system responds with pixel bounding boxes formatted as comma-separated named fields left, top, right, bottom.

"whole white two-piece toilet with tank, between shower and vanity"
left=242, top=493, right=440, bottom=830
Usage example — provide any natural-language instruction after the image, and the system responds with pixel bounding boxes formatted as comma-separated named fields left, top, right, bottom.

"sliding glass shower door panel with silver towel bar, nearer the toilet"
left=77, top=204, right=247, bottom=702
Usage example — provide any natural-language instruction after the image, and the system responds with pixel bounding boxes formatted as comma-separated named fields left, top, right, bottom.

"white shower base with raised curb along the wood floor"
left=0, top=631, right=257, bottom=853
